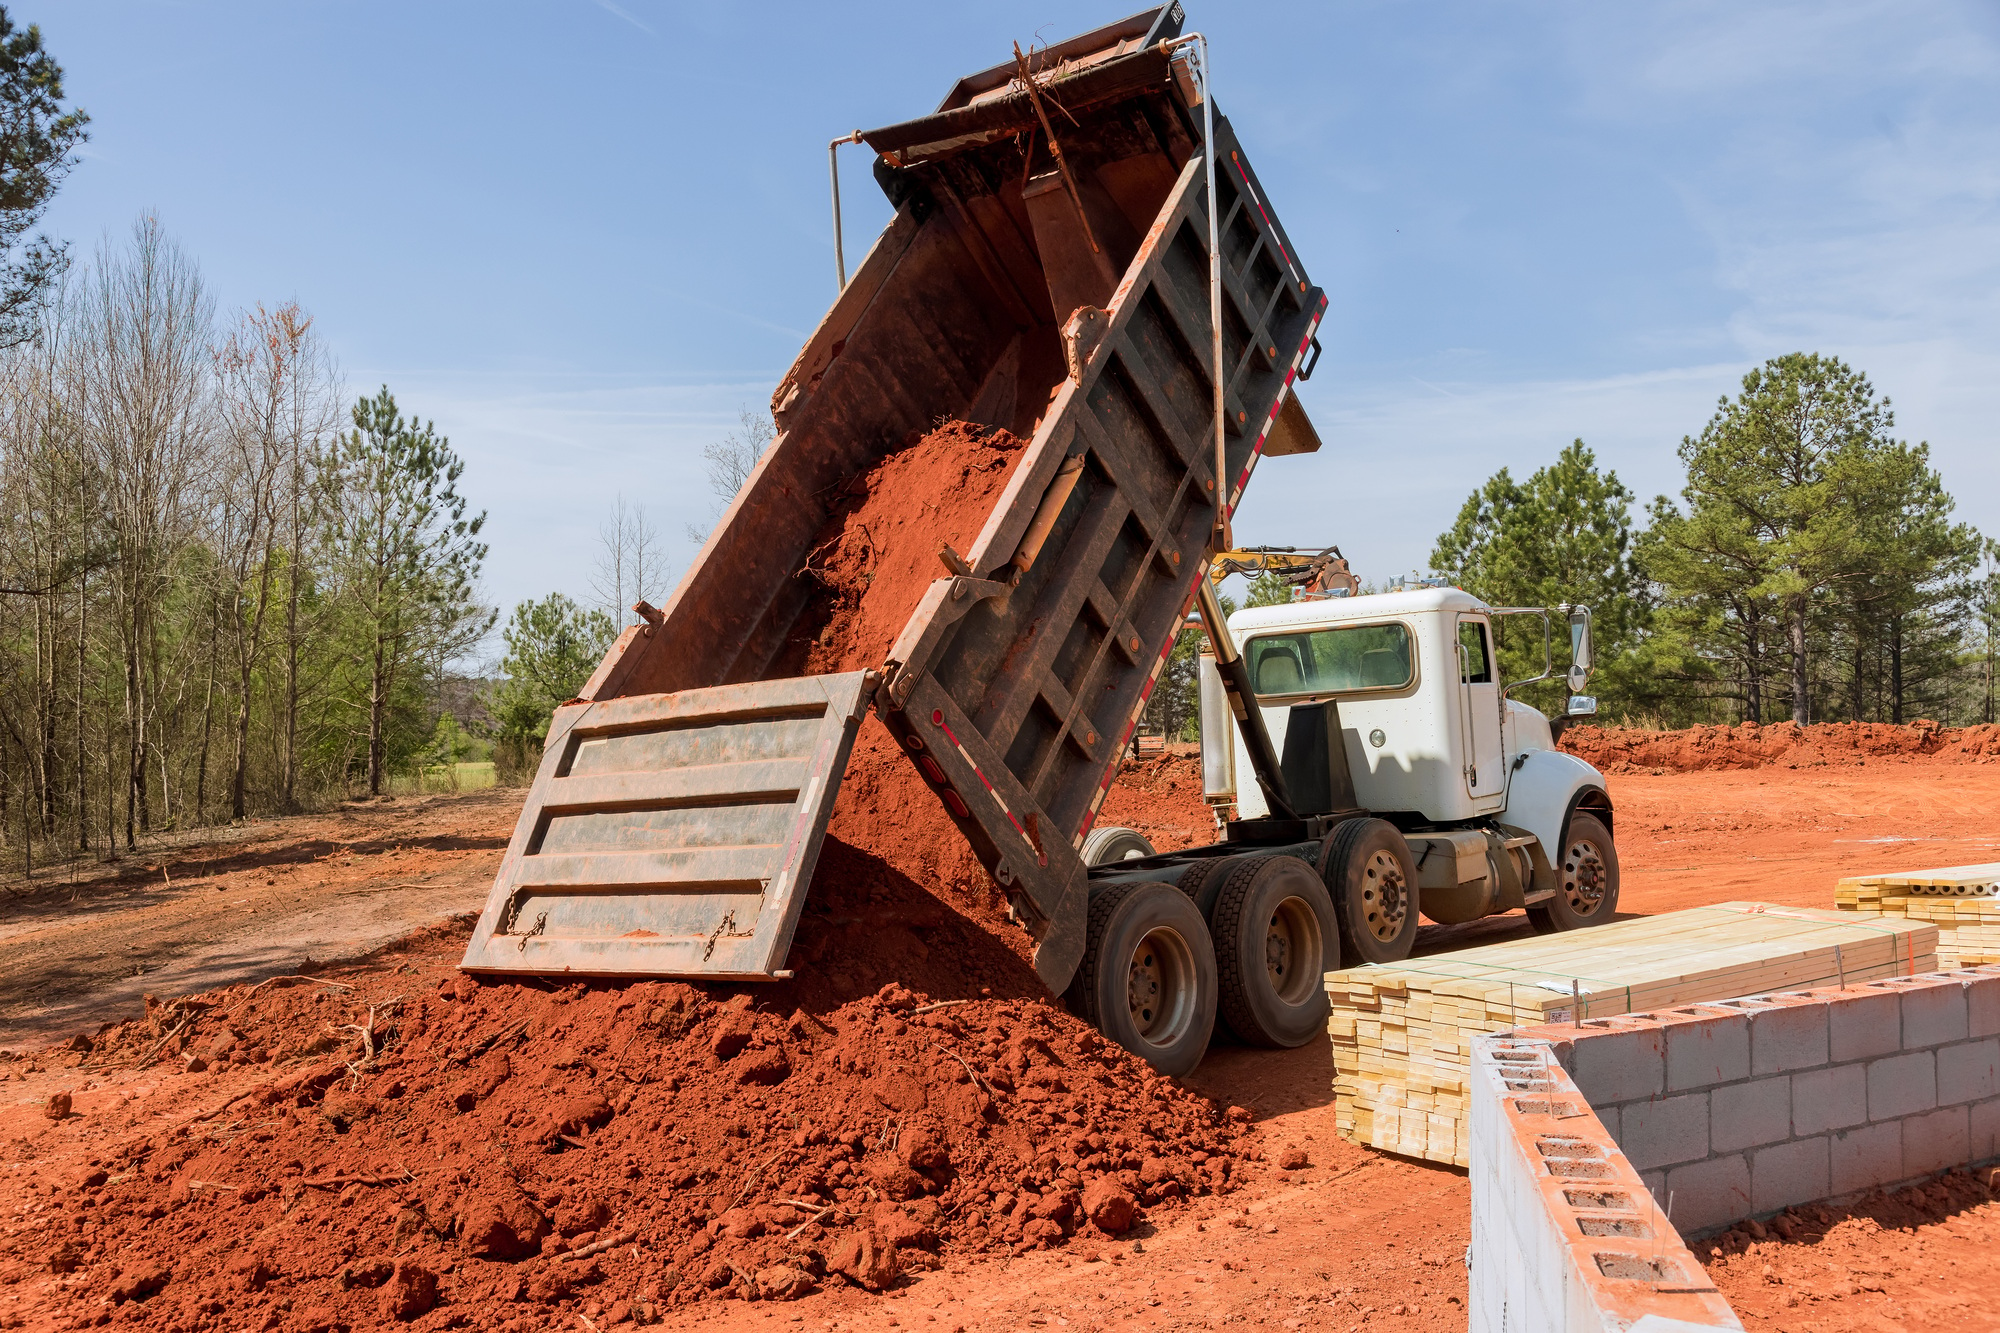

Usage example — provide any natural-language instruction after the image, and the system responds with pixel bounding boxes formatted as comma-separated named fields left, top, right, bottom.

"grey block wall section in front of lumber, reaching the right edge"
left=1518, top=965, right=2000, bottom=1233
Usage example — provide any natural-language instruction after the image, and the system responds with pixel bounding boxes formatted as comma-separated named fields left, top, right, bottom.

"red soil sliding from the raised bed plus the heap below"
left=3, top=422, right=1262, bottom=1331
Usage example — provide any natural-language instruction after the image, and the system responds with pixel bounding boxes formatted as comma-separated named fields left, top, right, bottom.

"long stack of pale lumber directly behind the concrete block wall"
left=1326, top=903, right=1938, bottom=1167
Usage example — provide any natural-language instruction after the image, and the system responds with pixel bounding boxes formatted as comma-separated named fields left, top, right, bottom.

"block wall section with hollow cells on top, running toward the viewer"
left=1468, top=1035, right=1742, bottom=1333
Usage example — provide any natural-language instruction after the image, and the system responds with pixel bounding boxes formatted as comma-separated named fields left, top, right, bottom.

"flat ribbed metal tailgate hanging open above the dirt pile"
left=462, top=671, right=874, bottom=979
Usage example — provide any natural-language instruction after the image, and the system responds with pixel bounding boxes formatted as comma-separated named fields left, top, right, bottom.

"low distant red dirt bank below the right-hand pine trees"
left=1562, top=719, right=2000, bottom=773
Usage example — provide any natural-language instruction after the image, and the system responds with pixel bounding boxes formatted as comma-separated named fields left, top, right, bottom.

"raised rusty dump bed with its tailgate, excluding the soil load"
left=464, top=4, right=1324, bottom=989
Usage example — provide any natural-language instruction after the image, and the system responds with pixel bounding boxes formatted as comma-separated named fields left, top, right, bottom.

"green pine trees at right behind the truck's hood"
left=1430, top=352, right=2000, bottom=727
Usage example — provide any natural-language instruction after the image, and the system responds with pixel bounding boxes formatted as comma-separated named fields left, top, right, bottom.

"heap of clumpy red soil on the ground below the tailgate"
left=0, top=931, right=1262, bottom=1331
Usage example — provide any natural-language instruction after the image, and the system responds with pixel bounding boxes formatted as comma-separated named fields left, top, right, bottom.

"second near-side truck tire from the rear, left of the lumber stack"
left=1208, top=857, right=1340, bottom=1047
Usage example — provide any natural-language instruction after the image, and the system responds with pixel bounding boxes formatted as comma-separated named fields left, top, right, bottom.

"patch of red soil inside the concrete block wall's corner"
left=1694, top=1171, right=2000, bottom=1333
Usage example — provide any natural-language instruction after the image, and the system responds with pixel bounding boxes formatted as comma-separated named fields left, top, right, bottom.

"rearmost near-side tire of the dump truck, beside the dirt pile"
left=1064, top=881, right=1216, bottom=1077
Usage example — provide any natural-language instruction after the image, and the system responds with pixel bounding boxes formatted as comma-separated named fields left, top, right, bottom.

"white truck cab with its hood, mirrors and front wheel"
left=1200, top=586, right=1618, bottom=944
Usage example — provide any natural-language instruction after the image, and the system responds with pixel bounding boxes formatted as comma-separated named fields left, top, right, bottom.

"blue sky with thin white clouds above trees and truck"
left=35, top=0, right=2000, bottom=628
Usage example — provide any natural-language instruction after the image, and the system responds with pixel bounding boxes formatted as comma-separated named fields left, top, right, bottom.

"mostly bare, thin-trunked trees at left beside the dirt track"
left=0, top=218, right=492, bottom=869
